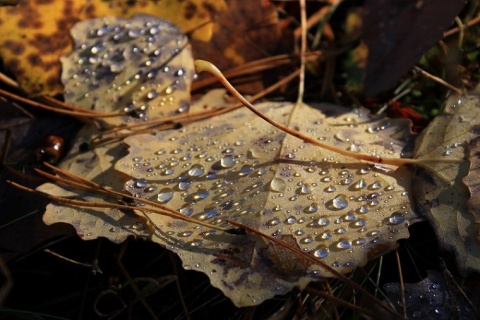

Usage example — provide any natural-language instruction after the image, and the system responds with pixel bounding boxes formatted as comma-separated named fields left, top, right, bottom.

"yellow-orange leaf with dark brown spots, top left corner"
left=0, top=0, right=226, bottom=95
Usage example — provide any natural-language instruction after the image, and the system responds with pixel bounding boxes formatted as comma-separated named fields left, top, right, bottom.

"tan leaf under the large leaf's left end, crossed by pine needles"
left=37, top=126, right=150, bottom=243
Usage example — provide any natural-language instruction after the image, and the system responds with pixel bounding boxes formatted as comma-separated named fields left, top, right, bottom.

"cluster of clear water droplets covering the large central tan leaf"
left=117, top=102, right=412, bottom=274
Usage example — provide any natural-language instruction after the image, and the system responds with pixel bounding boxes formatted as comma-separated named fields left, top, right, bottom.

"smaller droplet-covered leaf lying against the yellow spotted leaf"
left=61, top=14, right=194, bottom=124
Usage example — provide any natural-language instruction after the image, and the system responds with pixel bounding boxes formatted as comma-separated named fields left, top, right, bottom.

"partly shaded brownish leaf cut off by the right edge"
left=413, top=95, right=480, bottom=272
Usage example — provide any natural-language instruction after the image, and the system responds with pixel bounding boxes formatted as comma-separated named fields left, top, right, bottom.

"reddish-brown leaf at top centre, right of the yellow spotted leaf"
left=192, top=0, right=293, bottom=93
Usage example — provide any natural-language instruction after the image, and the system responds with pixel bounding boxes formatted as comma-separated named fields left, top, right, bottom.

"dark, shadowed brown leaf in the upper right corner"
left=362, top=0, right=465, bottom=96
